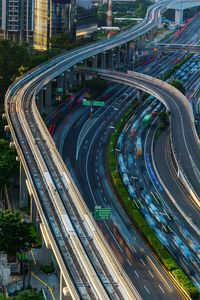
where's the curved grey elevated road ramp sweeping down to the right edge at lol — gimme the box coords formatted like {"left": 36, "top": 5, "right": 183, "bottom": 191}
{"left": 79, "top": 69, "right": 200, "bottom": 206}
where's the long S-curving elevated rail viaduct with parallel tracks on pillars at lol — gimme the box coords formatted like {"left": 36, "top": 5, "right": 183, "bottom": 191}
{"left": 5, "top": 0, "right": 200, "bottom": 299}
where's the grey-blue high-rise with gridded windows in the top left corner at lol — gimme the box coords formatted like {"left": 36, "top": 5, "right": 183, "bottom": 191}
{"left": 0, "top": 0, "right": 34, "bottom": 44}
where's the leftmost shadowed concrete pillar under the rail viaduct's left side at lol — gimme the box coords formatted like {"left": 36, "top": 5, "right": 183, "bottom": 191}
{"left": 19, "top": 162, "right": 29, "bottom": 208}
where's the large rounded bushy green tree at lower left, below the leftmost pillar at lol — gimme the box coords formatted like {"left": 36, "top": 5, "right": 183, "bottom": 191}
{"left": 0, "top": 210, "right": 35, "bottom": 258}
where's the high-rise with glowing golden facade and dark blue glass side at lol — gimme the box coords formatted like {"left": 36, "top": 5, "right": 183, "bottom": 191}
{"left": 34, "top": 0, "right": 76, "bottom": 50}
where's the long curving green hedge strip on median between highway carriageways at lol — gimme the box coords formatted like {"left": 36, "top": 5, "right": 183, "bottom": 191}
{"left": 107, "top": 101, "right": 199, "bottom": 299}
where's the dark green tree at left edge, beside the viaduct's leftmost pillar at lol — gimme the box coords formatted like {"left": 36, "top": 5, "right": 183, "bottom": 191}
{"left": 0, "top": 139, "right": 18, "bottom": 189}
